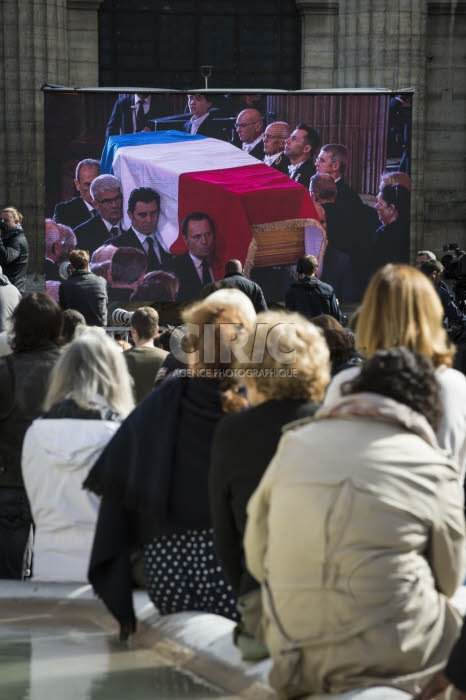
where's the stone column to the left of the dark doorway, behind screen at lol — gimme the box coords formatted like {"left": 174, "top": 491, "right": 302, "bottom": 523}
{"left": 0, "top": 0, "right": 100, "bottom": 274}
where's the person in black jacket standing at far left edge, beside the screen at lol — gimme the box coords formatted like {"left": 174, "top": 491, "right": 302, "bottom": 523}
{"left": 0, "top": 207, "right": 29, "bottom": 293}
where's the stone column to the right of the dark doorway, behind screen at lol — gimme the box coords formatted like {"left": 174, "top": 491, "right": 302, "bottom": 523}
{"left": 296, "top": 0, "right": 427, "bottom": 248}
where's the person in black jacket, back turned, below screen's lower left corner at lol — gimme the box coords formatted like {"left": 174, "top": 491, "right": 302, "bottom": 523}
{"left": 58, "top": 250, "right": 108, "bottom": 326}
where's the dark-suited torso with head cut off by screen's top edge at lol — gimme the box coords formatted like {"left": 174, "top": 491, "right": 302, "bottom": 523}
{"left": 105, "top": 92, "right": 166, "bottom": 139}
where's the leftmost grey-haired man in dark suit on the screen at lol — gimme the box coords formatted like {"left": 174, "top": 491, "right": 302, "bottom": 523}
{"left": 53, "top": 158, "right": 100, "bottom": 230}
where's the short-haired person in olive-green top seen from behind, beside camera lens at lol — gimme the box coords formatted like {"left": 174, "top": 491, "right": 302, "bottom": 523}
{"left": 124, "top": 306, "right": 168, "bottom": 403}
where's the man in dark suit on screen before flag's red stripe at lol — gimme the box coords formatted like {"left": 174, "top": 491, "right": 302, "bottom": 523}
{"left": 171, "top": 212, "right": 215, "bottom": 301}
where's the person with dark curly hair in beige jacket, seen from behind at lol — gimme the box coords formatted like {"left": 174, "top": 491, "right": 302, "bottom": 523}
{"left": 244, "top": 347, "right": 466, "bottom": 699}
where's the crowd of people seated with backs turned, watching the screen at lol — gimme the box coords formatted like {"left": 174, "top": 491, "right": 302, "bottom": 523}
{"left": 0, "top": 264, "right": 466, "bottom": 698}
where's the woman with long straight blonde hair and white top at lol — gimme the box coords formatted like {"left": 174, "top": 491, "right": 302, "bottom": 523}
{"left": 324, "top": 264, "right": 466, "bottom": 483}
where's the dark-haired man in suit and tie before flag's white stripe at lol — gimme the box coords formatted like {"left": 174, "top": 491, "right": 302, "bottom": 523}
{"left": 106, "top": 187, "right": 173, "bottom": 272}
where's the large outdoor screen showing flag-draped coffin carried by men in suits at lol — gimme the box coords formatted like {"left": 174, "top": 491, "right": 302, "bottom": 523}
{"left": 44, "top": 88, "right": 412, "bottom": 308}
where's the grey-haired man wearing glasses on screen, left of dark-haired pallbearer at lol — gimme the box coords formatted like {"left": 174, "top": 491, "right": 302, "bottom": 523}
{"left": 75, "top": 175, "right": 123, "bottom": 256}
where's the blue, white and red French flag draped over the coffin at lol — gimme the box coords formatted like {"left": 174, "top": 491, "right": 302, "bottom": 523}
{"left": 101, "top": 131, "right": 323, "bottom": 279}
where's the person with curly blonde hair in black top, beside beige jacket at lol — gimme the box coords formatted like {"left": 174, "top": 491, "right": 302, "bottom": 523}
{"left": 209, "top": 311, "right": 330, "bottom": 658}
